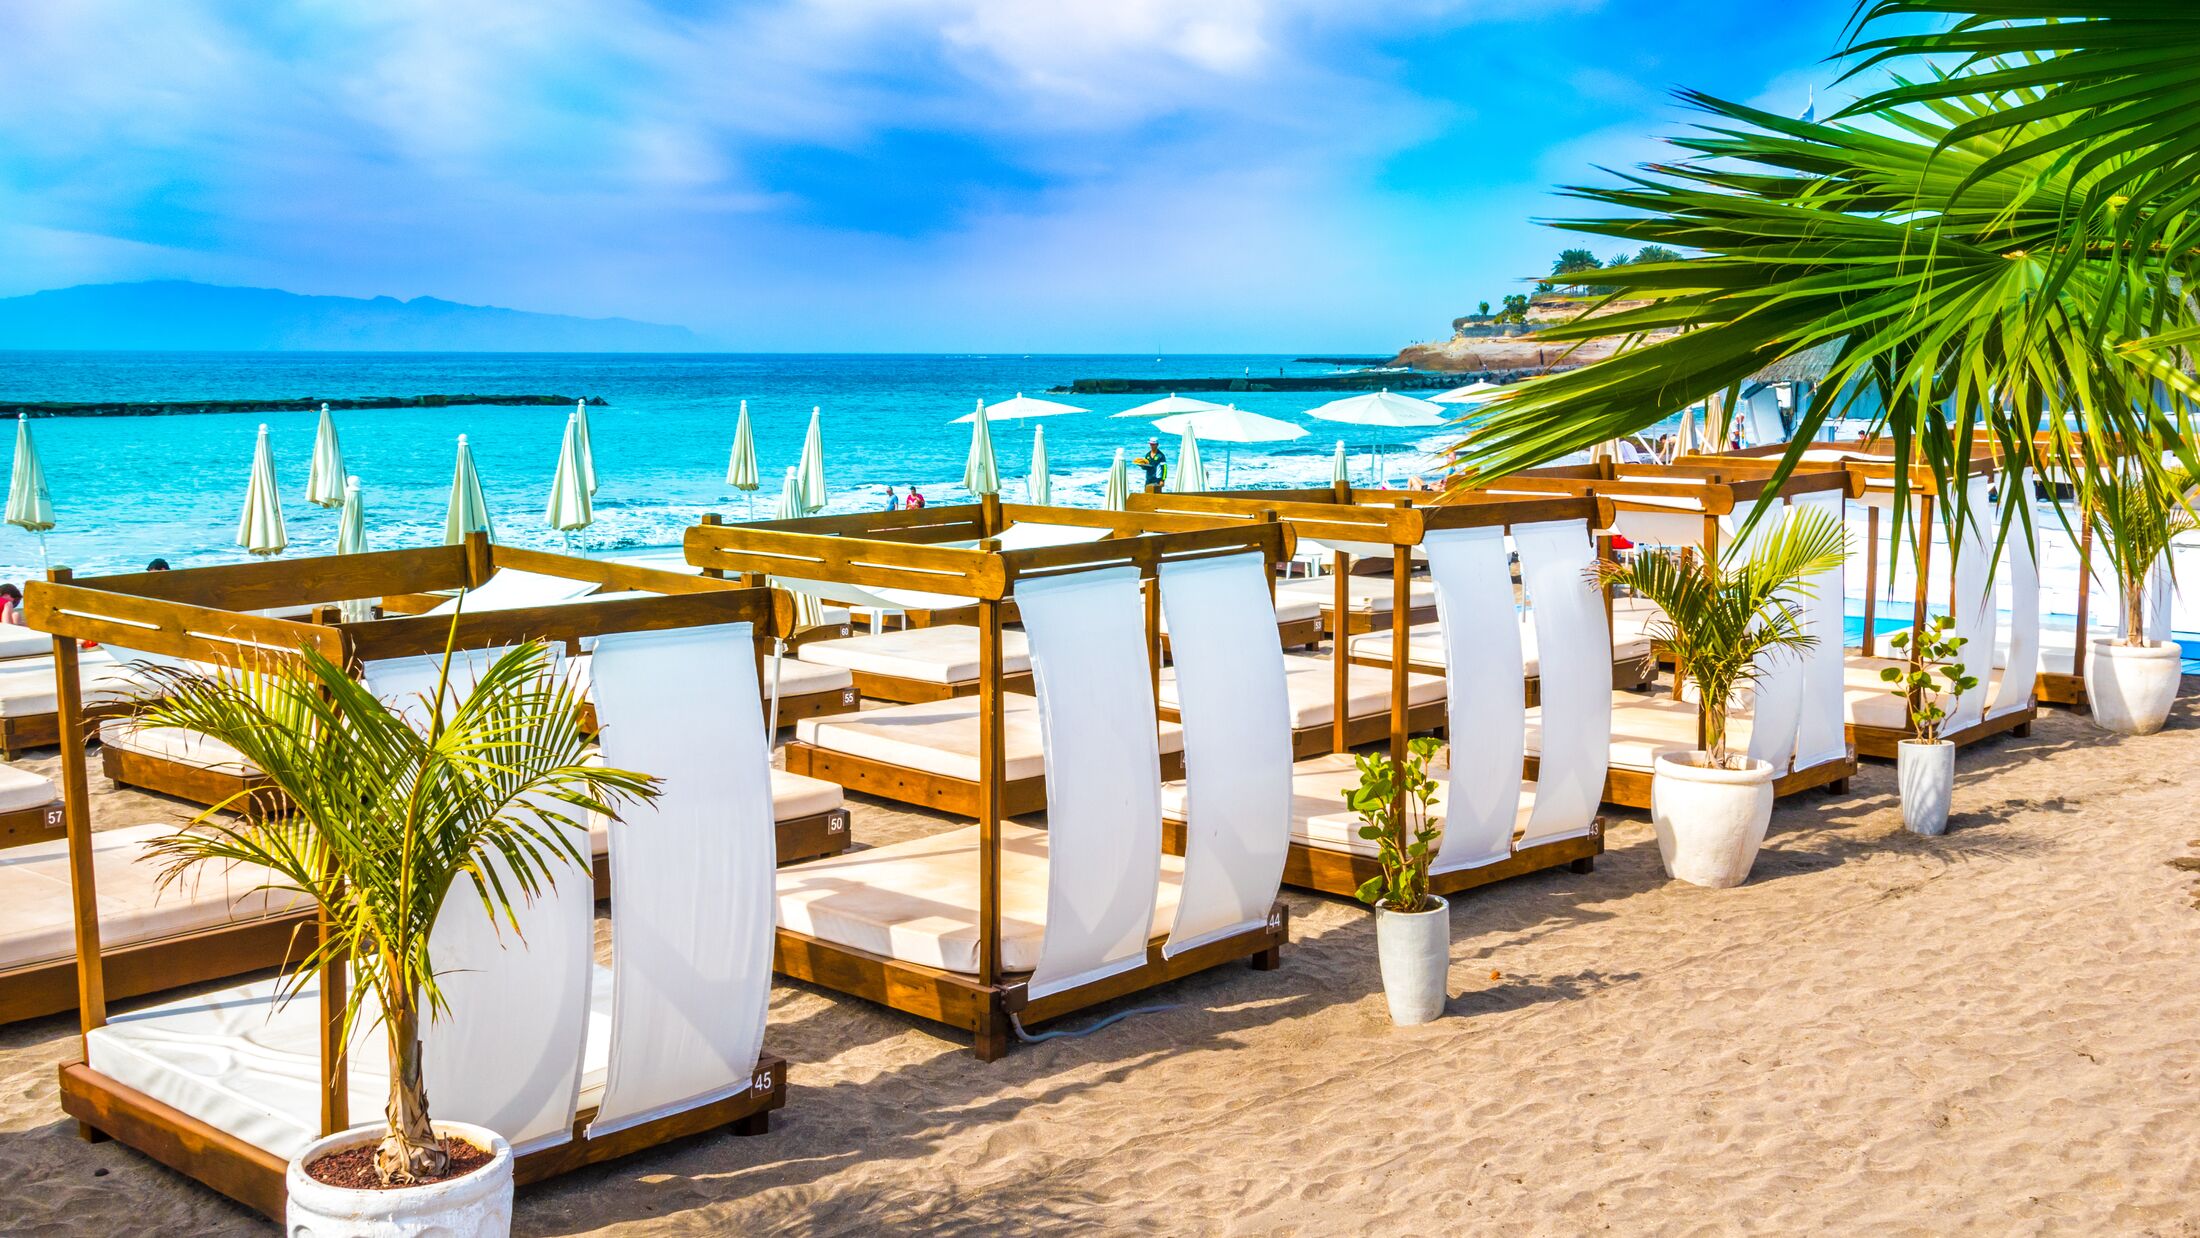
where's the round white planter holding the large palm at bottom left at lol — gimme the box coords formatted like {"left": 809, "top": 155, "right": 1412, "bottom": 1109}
{"left": 284, "top": 1121, "right": 513, "bottom": 1238}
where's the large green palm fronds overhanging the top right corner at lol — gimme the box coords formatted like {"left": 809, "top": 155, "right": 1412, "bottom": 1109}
{"left": 1459, "top": 0, "right": 2200, "bottom": 543}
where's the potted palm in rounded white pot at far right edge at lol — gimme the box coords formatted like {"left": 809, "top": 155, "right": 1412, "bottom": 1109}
{"left": 2079, "top": 460, "right": 2196, "bottom": 734}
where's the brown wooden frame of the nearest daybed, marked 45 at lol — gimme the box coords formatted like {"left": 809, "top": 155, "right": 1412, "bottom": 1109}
{"left": 19, "top": 534, "right": 792, "bottom": 1218}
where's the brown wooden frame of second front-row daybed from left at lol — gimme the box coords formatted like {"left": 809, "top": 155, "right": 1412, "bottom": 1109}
{"left": 686, "top": 508, "right": 1289, "bottom": 1062}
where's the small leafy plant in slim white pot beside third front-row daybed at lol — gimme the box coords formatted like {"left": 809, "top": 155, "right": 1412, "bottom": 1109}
{"left": 1344, "top": 737, "right": 1452, "bottom": 1027}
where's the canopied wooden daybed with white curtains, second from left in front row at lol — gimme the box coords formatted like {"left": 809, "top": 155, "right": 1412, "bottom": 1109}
{"left": 686, "top": 512, "right": 1289, "bottom": 1060}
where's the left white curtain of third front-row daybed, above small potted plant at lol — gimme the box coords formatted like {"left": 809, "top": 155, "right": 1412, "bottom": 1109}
{"left": 1423, "top": 528, "right": 1527, "bottom": 873}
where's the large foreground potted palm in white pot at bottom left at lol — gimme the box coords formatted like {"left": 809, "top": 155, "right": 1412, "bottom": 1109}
{"left": 147, "top": 642, "right": 656, "bottom": 1236}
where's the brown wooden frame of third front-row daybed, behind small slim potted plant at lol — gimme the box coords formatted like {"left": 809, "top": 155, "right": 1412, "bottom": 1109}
{"left": 1131, "top": 486, "right": 1613, "bottom": 897}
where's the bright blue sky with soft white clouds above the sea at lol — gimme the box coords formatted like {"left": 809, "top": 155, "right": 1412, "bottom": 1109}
{"left": 0, "top": 0, "right": 1852, "bottom": 352}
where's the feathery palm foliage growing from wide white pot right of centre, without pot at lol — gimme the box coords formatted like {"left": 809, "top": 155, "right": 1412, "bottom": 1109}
{"left": 1595, "top": 508, "right": 1848, "bottom": 770}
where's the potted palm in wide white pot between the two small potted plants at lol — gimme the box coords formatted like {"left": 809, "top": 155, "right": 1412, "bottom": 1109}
{"left": 1597, "top": 508, "right": 1848, "bottom": 888}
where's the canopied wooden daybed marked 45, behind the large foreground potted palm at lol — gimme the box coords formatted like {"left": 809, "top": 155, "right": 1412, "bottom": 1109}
{"left": 27, "top": 539, "right": 785, "bottom": 1218}
